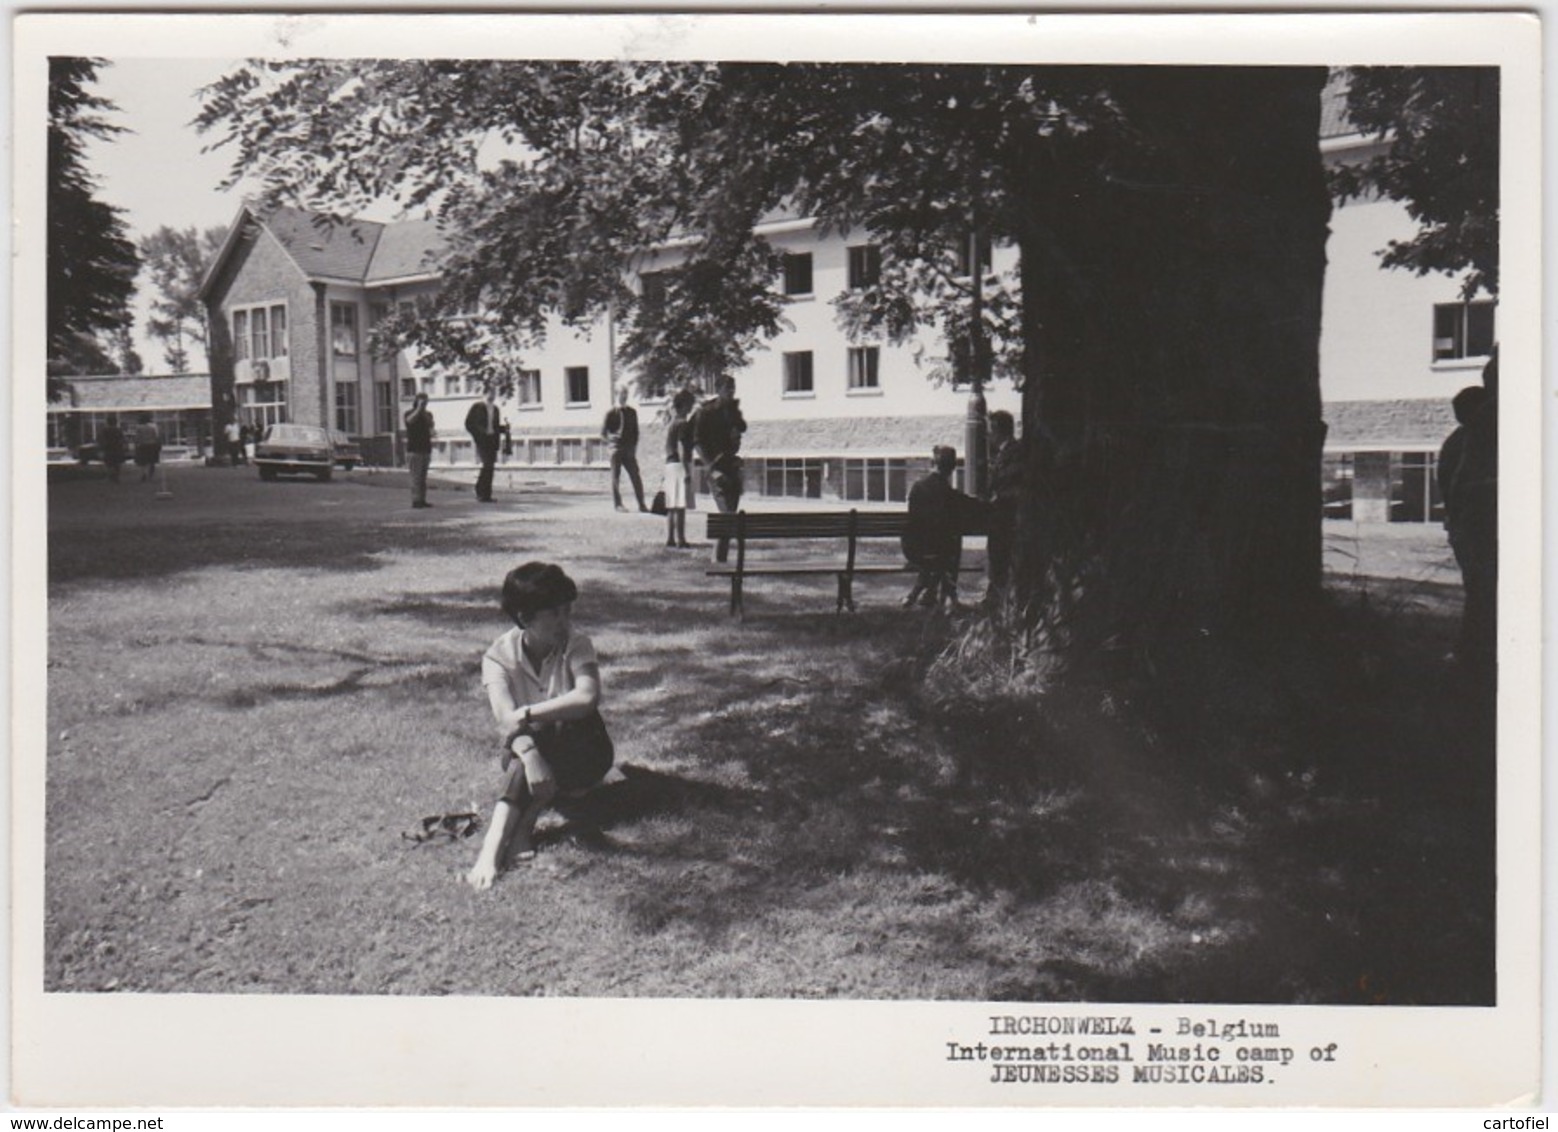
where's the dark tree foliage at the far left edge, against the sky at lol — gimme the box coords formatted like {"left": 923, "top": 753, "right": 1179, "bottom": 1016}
{"left": 47, "top": 58, "right": 139, "bottom": 378}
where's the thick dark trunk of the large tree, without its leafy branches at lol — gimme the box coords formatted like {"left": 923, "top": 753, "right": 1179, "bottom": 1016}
{"left": 1019, "top": 67, "right": 1331, "bottom": 660}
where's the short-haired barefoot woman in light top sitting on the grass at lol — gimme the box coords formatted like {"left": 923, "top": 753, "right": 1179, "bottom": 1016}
{"left": 466, "top": 562, "right": 614, "bottom": 892}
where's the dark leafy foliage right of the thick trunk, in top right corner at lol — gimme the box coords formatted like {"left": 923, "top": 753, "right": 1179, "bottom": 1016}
{"left": 1332, "top": 67, "right": 1499, "bottom": 299}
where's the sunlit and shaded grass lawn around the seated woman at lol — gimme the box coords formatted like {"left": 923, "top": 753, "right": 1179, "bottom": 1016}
{"left": 45, "top": 469, "right": 1494, "bottom": 1004}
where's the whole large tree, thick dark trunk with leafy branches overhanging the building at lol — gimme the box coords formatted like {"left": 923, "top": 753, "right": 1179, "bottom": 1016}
{"left": 199, "top": 61, "right": 1329, "bottom": 660}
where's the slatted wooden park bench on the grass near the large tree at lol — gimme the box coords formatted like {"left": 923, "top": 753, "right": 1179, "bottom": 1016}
{"left": 706, "top": 511, "right": 989, "bottom": 617}
